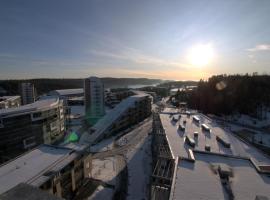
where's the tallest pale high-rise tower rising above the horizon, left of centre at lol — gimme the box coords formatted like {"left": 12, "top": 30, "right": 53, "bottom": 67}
{"left": 84, "top": 77, "right": 105, "bottom": 125}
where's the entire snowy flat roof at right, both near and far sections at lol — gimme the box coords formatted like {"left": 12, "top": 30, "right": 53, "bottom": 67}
{"left": 160, "top": 110, "right": 270, "bottom": 200}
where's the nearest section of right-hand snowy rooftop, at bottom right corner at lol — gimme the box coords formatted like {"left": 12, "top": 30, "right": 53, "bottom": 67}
{"left": 172, "top": 153, "right": 270, "bottom": 200}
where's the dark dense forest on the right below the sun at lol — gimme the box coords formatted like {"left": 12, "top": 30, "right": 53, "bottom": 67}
{"left": 186, "top": 74, "right": 270, "bottom": 117}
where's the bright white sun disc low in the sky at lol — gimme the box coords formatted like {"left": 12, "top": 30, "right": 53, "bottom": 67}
{"left": 188, "top": 44, "right": 214, "bottom": 67}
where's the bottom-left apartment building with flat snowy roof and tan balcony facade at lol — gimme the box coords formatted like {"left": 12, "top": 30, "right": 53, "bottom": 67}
{"left": 0, "top": 144, "right": 86, "bottom": 199}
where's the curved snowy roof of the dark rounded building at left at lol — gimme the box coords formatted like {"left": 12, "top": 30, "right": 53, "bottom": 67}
{"left": 0, "top": 98, "right": 59, "bottom": 117}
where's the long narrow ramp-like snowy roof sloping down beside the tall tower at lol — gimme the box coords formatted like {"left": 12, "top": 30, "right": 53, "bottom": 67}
{"left": 80, "top": 92, "right": 149, "bottom": 144}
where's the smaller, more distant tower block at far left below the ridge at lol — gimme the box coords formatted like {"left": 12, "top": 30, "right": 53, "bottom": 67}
{"left": 21, "top": 83, "right": 36, "bottom": 105}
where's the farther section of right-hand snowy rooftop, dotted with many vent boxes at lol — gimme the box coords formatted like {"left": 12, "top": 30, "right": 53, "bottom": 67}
{"left": 160, "top": 111, "right": 270, "bottom": 165}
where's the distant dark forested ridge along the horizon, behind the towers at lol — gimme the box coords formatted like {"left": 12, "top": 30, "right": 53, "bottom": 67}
{"left": 0, "top": 77, "right": 162, "bottom": 95}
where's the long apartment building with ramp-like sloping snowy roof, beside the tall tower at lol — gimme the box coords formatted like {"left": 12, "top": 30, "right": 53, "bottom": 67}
{"left": 80, "top": 91, "right": 152, "bottom": 144}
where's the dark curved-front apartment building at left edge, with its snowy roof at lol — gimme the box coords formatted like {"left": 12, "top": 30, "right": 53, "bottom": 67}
{"left": 0, "top": 98, "right": 65, "bottom": 163}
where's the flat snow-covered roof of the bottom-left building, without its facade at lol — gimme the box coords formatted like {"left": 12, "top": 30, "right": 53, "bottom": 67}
{"left": 0, "top": 145, "right": 77, "bottom": 194}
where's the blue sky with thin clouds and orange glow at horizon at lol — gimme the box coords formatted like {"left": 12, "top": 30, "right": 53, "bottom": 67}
{"left": 0, "top": 0, "right": 270, "bottom": 80}
